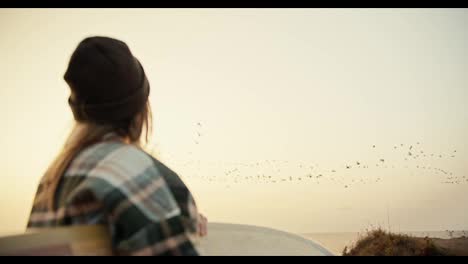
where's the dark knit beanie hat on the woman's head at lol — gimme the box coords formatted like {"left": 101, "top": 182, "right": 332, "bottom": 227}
{"left": 64, "top": 37, "right": 150, "bottom": 124}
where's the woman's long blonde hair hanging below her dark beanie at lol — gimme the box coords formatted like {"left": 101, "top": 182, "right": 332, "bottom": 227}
{"left": 34, "top": 101, "right": 152, "bottom": 210}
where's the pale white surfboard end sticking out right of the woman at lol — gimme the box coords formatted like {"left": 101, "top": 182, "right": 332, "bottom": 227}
{"left": 197, "top": 223, "right": 333, "bottom": 256}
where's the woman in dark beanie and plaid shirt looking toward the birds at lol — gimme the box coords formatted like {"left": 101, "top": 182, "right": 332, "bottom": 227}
{"left": 28, "top": 37, "right": 206, "bottom": 255}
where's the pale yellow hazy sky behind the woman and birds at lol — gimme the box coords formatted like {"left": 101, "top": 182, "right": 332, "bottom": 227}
{"left": 0, "top": 9, "right": 468, "bottom": 234}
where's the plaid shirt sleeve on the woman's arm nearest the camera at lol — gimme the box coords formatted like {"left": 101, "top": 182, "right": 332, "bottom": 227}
{"left": 98, "top": 152, "right": 199, "bottom": 256}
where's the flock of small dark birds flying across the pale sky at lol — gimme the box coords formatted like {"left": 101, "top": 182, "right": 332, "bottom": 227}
{"left": 165, "top": 122, "right": 468, "bottom": 188}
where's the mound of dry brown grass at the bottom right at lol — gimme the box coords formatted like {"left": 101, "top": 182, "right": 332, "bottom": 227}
{"left": 343, "top": 229, "right": 450, "bottom": 256}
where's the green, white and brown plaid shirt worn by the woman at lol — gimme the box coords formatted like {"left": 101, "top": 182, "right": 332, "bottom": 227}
{"left": 28, "top": 141, "right": 199, "bottom": 255}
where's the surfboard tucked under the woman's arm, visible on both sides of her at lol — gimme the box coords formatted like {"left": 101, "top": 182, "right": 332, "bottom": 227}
{"left": 0, "top": 223, "right": 332, "bottom": 256}
